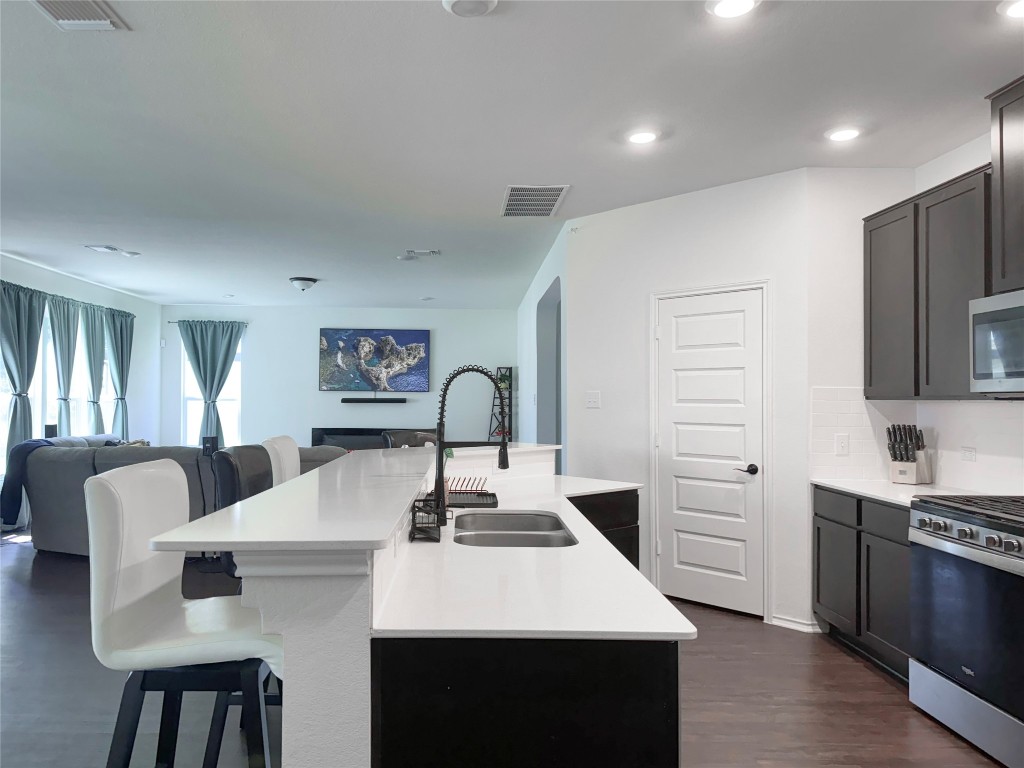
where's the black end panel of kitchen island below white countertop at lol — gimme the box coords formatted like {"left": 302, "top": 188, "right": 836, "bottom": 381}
{"left": 372, "top": 638, "right": 680, "bottom": 768}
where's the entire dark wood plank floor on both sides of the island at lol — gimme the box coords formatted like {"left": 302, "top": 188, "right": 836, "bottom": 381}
{"left": 0, "top": 544, "right": 995, "bottom": 768}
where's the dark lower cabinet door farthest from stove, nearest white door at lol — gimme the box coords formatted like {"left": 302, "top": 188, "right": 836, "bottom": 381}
{"left": 814, "top": 516, "right": 857, "bottom": 635}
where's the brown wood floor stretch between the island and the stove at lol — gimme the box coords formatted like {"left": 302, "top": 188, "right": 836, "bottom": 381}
{"left": 673, "top": 601, "right": 998, "bottom": 768}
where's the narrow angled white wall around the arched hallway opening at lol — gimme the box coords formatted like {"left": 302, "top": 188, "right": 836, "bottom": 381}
{"left": 516, "top": 224, "right": 571, "bottom": 456}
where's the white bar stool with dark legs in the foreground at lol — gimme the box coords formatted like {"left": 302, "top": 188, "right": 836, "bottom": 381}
{"left": 85, "top": 459, "right": 284, "bottom": 768}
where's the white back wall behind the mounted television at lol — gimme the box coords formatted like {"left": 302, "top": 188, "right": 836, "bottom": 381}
{"left": 161, "top": 306, "right": 516, "bottom": 445}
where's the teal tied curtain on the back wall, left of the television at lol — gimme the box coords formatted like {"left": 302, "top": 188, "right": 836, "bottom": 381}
{"left": 178, "top": 321, "right": 246, "bottom": 443}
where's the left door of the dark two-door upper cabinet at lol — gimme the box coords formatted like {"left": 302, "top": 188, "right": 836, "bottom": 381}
{"left": 864, "top": 203, "right": 921, "bottom": 399}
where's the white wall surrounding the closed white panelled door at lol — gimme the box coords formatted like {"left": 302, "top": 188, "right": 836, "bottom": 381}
{"left": 566, "top": 171, "right": 811, "bottom": 623}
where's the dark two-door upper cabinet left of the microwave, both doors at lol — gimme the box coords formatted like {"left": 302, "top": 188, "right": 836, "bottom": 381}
{"left": 864, "top": 166, "right": 991, "bottom": 400}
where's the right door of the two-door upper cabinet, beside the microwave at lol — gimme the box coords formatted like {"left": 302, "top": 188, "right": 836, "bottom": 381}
{"left": 918, "top": 167, "right": 990, "bottom": 398}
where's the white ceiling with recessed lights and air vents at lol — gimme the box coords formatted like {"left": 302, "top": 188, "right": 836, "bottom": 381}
{"left": 0, "top": 0, "right": 1024, "bottom": 307}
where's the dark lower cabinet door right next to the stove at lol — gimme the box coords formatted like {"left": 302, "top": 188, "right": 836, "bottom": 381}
{"left": 860, "top": 532, "right": 910, "bottom": 677}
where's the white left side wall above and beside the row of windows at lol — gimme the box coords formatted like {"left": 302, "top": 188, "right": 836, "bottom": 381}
{"left": 0, "top": 255, "right": 160, "bottom": 444}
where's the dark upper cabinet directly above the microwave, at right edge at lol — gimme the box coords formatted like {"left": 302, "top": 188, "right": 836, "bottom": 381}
{"left": 988, "top": 78, "right": 1024, "bottom": 293}
